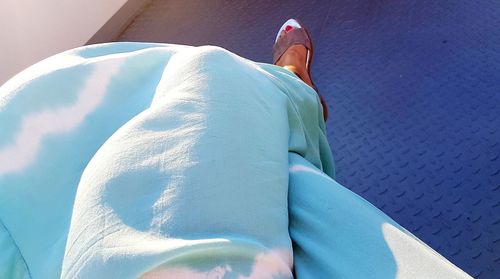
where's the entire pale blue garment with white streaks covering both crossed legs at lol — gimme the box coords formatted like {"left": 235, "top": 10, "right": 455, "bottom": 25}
{"left": 0, "top": 43, "right": 468, "bottom": 278}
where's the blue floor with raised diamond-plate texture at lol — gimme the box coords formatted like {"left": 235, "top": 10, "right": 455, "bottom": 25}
{"left": 119, "top": 0, "right": 500, "bottom": 278}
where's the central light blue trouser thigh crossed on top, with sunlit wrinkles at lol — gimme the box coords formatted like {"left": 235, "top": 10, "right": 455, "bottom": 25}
{"left": 62, "top": 47, "right": 292, "bottom": 278}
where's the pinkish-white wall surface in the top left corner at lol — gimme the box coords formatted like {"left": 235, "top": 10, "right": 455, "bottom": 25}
{"left": 0, "top": 0, "right": 127, "bottom": 85}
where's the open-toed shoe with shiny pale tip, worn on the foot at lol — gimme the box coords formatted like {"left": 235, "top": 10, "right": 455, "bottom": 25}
{"left": 273, "top": 18, "right": 328, "bottom": 121}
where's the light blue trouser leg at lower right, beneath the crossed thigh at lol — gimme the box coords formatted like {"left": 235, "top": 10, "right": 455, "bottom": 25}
{"left": 289, "top": 153, "right": 470, "bottom": 278}
